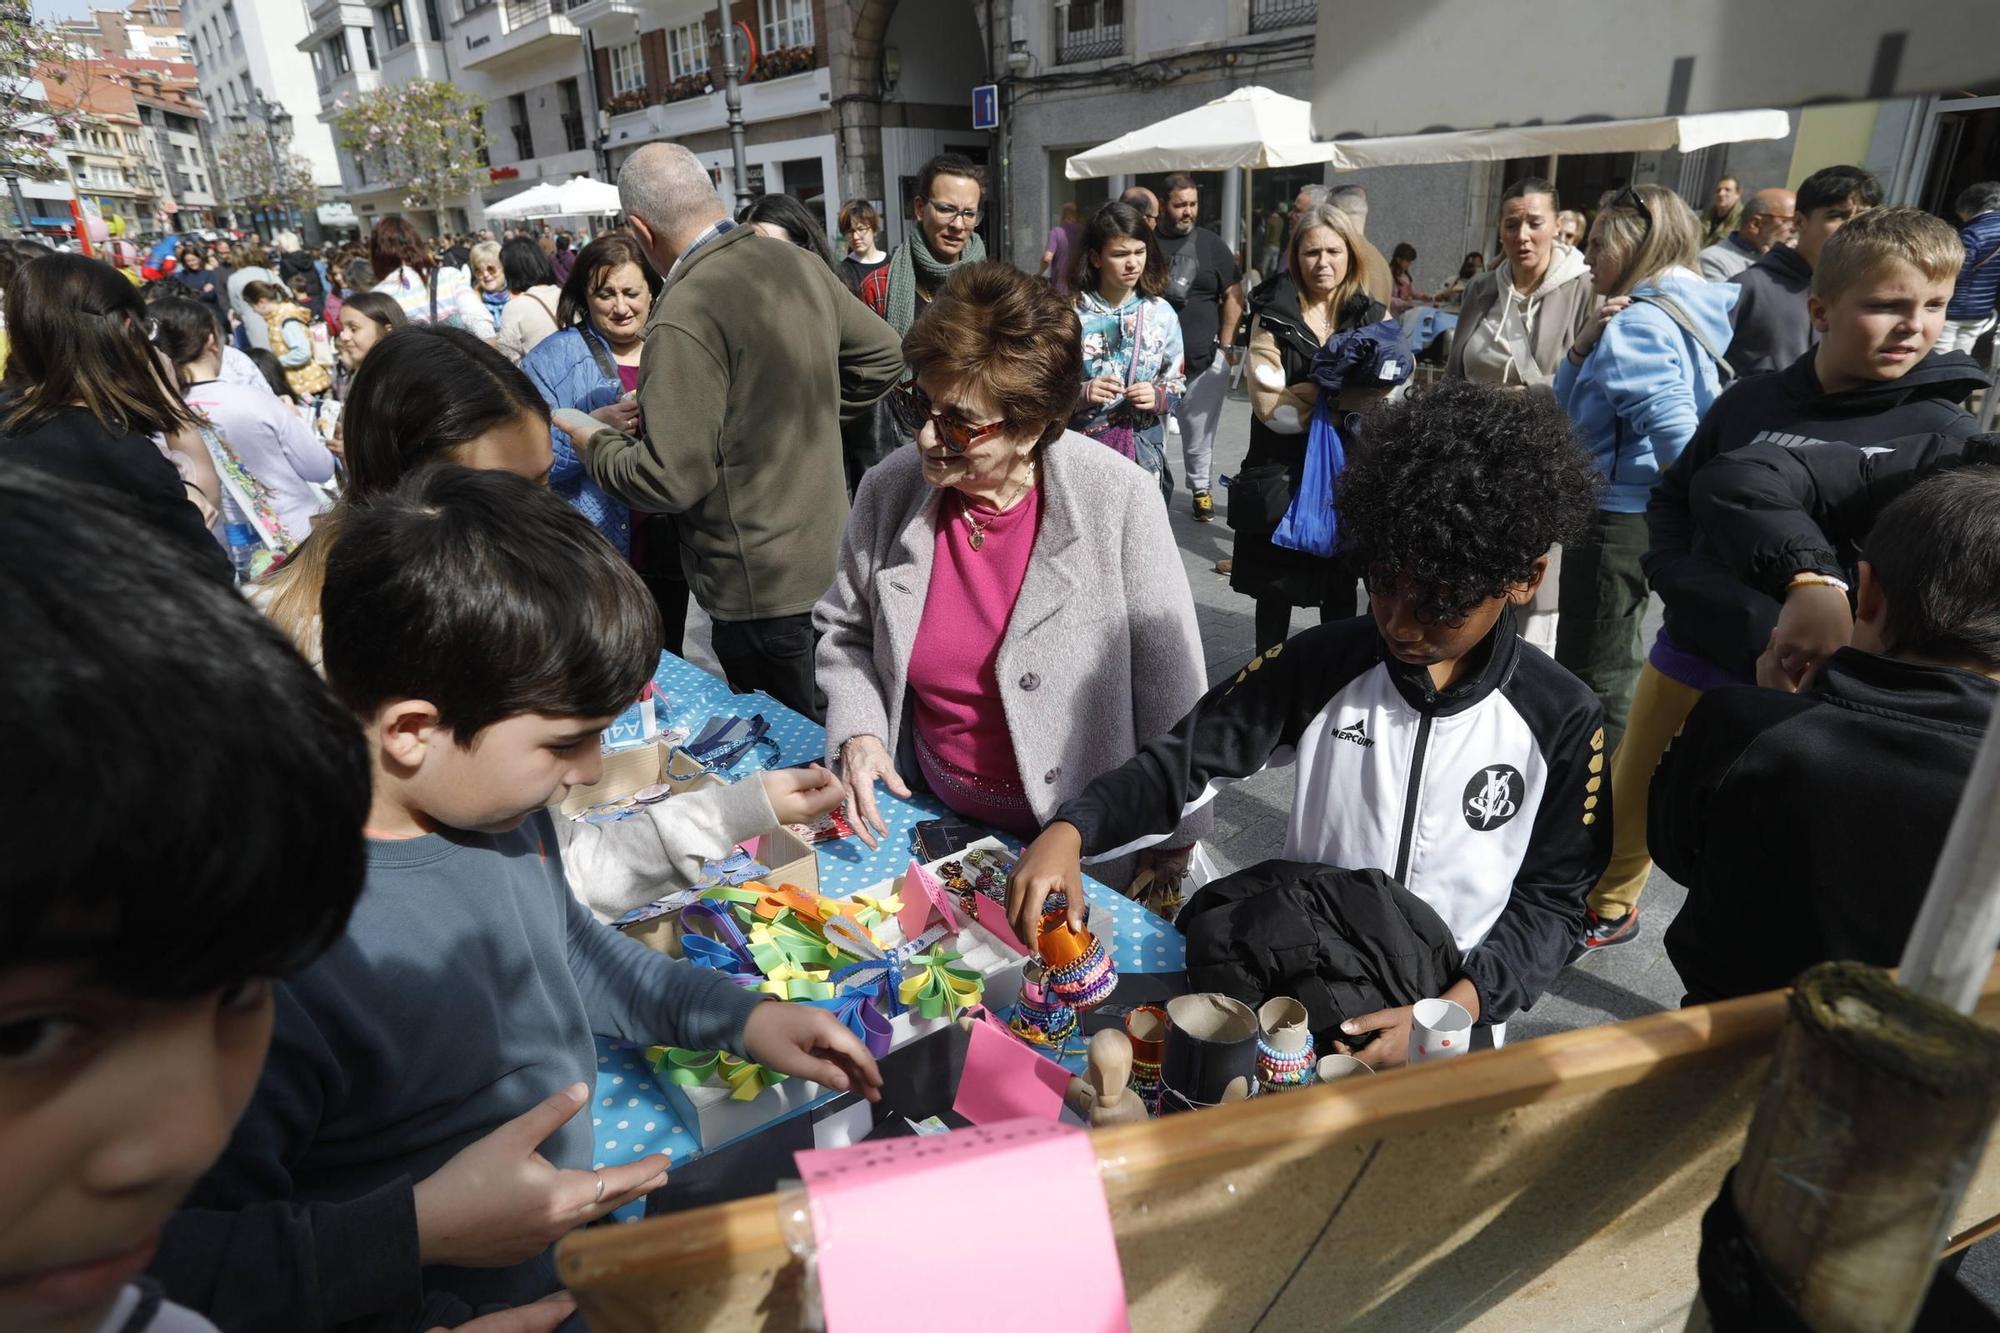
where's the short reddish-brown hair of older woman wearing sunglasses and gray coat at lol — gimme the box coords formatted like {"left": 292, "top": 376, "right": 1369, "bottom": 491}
{"left": 902, "top": 262, "right": 1084, "bottom": 450}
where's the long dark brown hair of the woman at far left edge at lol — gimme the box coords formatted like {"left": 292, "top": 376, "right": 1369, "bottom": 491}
{"left": 0, "top": 254, "right": 196, "bottom": 434}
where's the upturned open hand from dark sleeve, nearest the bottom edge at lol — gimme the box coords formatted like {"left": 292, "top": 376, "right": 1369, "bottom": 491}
{"left": 416, "top": 1072, "right": 672, "bottom": 1269}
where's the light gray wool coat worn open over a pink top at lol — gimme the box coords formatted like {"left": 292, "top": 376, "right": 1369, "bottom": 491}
{"left": 812, "top": 430, "right": 1210, "bottom": 885}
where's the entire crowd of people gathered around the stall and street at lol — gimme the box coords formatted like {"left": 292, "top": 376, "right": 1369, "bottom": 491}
{"left": 0, "top": 144, "right": 2000, "bottom": 1329}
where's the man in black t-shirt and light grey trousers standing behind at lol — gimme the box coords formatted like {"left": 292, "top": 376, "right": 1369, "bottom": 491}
{"left": 1154, "top": 172, "right": 1244, "bottom": 522}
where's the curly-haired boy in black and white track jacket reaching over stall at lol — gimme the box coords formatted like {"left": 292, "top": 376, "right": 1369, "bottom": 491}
{"left": 1010, "top": 382, "right": 1610, "bottom": 1067}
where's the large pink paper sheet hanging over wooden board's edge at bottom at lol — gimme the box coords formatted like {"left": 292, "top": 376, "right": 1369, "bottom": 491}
{"left": 796, "top": 1112, "right": 1132, "bottom": 1333}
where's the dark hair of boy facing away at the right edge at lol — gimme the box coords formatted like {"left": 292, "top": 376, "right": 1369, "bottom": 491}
{"left": 1862, "top": 466, "right": 2000, "bottom": 671}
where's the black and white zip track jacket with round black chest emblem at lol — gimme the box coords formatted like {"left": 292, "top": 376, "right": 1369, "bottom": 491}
{"left": 1056, "top": 608, "right": 1612, "bottom": 1023}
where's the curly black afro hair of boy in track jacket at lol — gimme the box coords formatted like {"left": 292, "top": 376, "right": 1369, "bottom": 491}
{"left": 1334, "top": 380, "right": 1598, "bottom": 622}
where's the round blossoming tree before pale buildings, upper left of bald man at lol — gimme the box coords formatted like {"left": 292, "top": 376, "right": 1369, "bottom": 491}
{"left": 334, "top": 78, "right": 486, "bottom": 208}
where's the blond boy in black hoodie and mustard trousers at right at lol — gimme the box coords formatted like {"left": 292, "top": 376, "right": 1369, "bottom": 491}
{"left": 1580, "top": 208, "right": 1986, "bottom": 951}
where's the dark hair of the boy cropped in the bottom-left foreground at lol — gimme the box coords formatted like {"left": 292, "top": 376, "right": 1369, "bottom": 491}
{"left": 0, "top": 462, "right": 368, "bottom": 999}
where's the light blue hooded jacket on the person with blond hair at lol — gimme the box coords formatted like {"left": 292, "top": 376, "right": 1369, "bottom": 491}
{"left": 1556, "top": 268, "right": 1738, "bottom": 514}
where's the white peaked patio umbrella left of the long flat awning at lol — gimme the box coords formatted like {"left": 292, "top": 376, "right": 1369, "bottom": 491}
{"left": 1062, "top": 88, "right": 1340, "bottom": 180}
